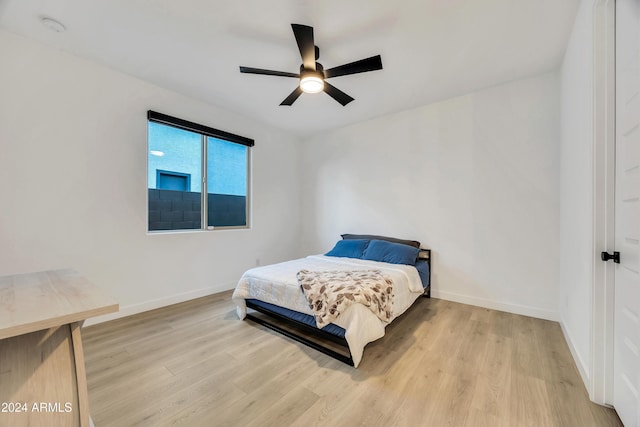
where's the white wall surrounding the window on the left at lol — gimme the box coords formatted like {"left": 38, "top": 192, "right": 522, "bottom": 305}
{"left": 0, "top": 31, "right": 300, "bottom": 322}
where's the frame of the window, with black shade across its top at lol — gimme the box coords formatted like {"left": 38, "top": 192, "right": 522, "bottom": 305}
{"left": 146, "top": 110, "right": 255, "bottom": 234}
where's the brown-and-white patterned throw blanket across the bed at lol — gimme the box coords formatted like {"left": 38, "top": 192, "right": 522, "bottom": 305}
{"left": 296, "top": 270, "right": 393, "bottom": 328}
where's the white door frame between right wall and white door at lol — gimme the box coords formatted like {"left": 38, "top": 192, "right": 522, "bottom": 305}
{"left": 586, "top": 0, "right": 616, "bottom": 406}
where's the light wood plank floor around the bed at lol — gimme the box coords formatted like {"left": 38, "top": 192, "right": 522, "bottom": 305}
{"left": 83, "top": 292, "right": 621, "bottom": 427}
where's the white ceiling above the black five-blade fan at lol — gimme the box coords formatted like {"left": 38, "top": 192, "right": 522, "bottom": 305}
{"left": 0, "top": 0, "right": 579, "bottom": 135}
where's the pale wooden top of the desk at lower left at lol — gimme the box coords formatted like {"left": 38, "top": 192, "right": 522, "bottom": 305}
{"left": 0, "top": 270, "right": 118, "bottom": 339}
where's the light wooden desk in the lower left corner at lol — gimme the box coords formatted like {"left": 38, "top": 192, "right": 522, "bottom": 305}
{"left": 0, "top": 270, "right": 118, "bottom": 427}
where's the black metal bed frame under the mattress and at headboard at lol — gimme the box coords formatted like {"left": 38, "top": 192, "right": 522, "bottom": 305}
{"left": 246, "top": 249, "right": 431, "bottom": 366}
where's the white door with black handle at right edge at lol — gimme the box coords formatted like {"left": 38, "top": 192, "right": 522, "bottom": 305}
{"left": 613, "top": 0, "right": 640, "bottom": 427}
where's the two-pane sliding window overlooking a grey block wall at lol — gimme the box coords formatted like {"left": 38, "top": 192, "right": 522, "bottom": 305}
{"left": 147, "top": 111, "right": 254, "bottom": 231}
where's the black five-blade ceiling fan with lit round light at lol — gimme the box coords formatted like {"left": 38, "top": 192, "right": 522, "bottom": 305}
{"left": 240, "top": 24, "right": 382, "bottom": 106}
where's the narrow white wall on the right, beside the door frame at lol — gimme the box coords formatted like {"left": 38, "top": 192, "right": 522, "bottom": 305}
{"left": 559, "top": 0, "right": 594, "bottom": 383}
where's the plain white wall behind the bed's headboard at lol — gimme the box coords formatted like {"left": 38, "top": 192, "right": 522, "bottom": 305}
{"left": 302, "top": 73, "right": 560, "bottom": 319}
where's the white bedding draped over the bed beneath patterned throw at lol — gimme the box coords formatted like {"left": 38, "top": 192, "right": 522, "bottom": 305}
{"left": 232, "top": 255, "right": 424, "bottom": 367}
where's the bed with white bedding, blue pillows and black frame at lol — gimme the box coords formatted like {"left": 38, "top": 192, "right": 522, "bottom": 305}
{"left": 232, "top": 234, "right": 431, "bottom": 367}
